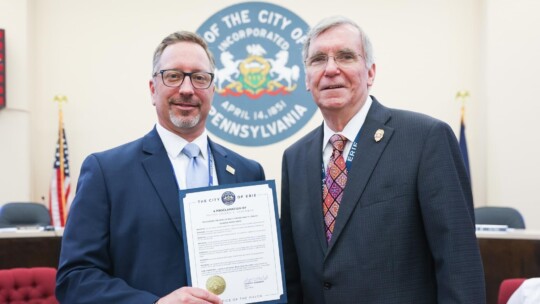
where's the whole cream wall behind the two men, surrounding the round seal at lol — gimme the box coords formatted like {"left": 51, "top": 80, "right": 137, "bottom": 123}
{"left": 0, "top": 0, "right": 540, "bottom": 229}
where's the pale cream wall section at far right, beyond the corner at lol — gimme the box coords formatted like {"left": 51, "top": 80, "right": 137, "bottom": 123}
{"left": 483, "top": 0, "right": 540, "bottom": 223}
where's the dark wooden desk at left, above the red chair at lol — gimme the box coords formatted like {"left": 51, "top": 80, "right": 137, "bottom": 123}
{"left": 0, "top": 231, "right": 62, "bottom": 269}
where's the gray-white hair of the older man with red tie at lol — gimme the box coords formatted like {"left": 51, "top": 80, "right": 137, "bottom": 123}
{"left": 302, "top": 16, "right": 375, "bottom": 69}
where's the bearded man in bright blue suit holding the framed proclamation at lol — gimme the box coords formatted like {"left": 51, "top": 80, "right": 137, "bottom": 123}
{"left": 56, "top": 32, "right": 265, "bottom": 304}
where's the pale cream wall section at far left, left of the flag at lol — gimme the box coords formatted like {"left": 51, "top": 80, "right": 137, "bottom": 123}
{"left": 0, "top": 0, "right": 31, "bottom": 204}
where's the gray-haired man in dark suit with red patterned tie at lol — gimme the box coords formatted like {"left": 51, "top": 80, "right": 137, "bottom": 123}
{"left": 281, "top": 17, "right": 485, "bottom": 304}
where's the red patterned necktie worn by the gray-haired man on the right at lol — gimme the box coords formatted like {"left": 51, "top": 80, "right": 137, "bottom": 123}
{"left": 323, "top": 134, "right": 347, "bottom": 243}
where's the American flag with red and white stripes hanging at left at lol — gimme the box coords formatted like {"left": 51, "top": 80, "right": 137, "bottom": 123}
{"left": 49, "top": 122, "right": 71, "bottom": 227}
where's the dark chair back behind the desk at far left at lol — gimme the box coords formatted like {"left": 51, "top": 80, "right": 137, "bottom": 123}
{"left": 0, "top": 203, "right": 51, "bottom": 228}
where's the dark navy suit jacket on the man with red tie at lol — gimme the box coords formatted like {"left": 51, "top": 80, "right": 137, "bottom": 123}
{"left": 281, "top": 99, "right": 485, "bottom": 304}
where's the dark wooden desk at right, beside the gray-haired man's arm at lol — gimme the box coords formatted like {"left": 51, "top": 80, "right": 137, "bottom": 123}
{"left": 476, "top": 230, "right": 540, "bottom": 304}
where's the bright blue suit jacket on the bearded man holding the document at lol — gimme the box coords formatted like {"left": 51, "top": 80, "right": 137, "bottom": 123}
{"left": 56, "top": 129, "right": 265, "bottom": 303}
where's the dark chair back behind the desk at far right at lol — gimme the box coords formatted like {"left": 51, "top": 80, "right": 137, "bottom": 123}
{"left": 474, "top": 207, "right": 525, "bottom": 229}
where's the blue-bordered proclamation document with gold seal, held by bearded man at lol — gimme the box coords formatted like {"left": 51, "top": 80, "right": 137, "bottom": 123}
{"left": 180, "top": 180, "right": 287, "bottom": 304}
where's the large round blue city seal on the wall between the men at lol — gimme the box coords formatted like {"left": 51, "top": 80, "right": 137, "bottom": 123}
{"left": 197, "top": 2, "right": 317, "bottom": 146}
